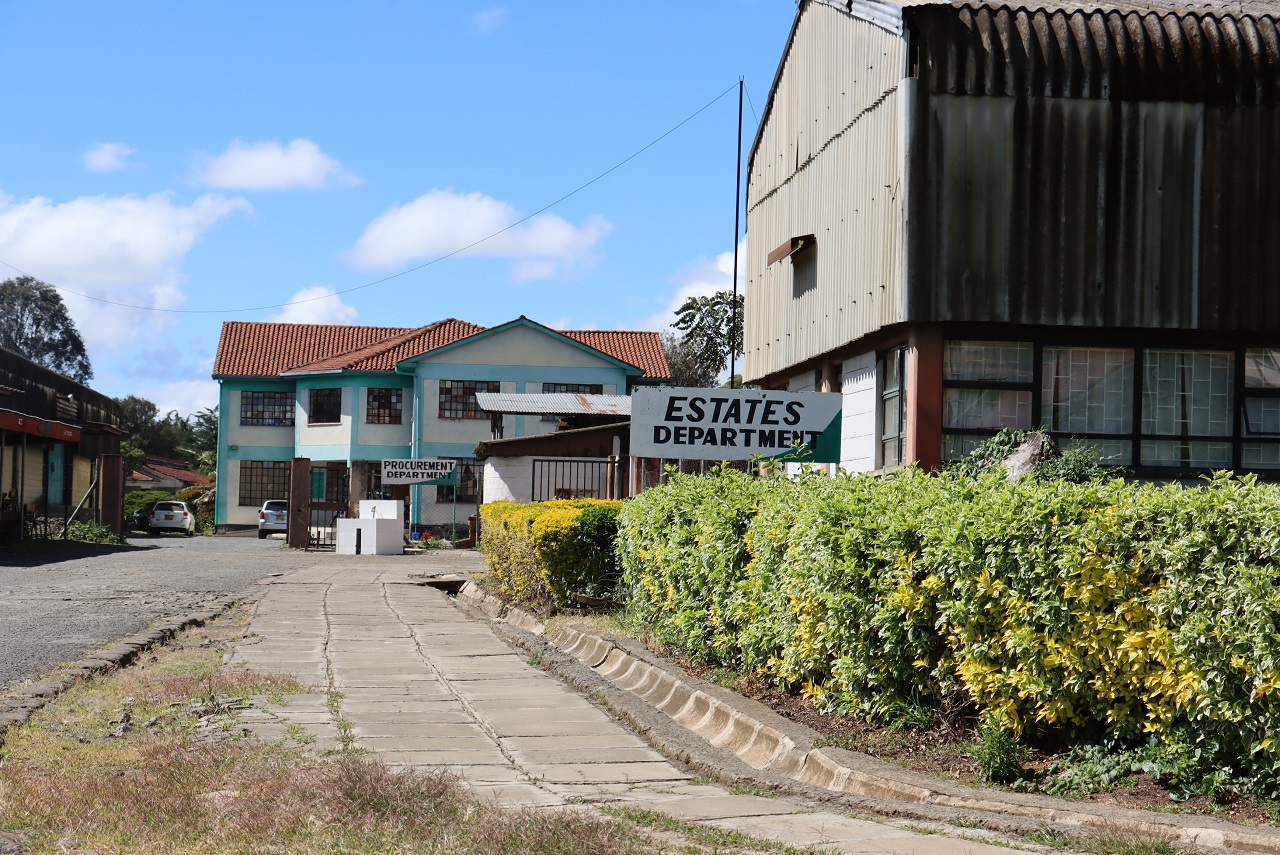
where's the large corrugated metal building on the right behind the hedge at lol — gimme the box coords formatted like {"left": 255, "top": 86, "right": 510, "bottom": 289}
{"left": 744, "top": 0, "right": 1280, "bottom": 477}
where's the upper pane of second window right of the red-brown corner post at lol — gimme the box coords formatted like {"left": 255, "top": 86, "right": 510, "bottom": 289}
{"left": 1041, "top": 347, "right": 1134, "bottom": 434}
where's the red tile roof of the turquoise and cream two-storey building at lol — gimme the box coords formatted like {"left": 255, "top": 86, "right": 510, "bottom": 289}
{"left": 214, "top": 317, "right": 671, "bottom": 379}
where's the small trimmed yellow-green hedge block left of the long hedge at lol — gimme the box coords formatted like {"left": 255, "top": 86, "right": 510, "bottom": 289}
{"left": 480, "top": 499, "right": 622, "bottom": 612}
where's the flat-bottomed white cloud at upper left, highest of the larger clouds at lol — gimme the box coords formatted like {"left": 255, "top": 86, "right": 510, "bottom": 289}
{"left": 195, "top": 140, "right": 360, "bottom": 189}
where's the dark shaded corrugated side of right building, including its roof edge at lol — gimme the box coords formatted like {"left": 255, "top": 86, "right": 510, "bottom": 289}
{"left": 909, "top": 6, "right": 1280, "bottom": 332}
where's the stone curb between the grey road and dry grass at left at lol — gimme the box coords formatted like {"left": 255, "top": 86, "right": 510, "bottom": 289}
{"left": 0, "top": 596, "right": 246, "bottom": 747}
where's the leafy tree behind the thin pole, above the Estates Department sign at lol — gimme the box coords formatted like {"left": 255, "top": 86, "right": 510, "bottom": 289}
{"left": 663, "top": 291, "right": 745, "bottom": 387}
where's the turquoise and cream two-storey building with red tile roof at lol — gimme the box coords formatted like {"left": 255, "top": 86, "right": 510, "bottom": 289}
{"left": 214, "top": 315, "right": 671, "bottom": 530}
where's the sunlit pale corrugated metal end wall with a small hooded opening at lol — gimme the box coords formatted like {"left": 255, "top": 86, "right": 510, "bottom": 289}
{"left": 744, "top": 3, "right": 913, "bottom": 380}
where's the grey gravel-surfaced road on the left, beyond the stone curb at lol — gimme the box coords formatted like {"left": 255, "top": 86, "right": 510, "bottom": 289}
{"left": 0, "top": 532, "right": 320, "bottom": 694}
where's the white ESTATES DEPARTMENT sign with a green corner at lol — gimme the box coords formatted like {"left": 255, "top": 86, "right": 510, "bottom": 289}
{"left": 631, "top": 387, "right": 844, "bottom": 463}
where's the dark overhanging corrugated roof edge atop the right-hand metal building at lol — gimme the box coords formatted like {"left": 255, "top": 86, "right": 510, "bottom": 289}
{"left": 902, "top": 1, "right": 1280, "bottom": 105}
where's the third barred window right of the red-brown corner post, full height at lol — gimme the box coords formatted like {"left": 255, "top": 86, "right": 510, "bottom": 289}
{"left": 1140, "top": 349, "right": 1235, "bottom": 468}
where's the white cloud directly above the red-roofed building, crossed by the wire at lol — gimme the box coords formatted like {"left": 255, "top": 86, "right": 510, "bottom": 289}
{"left": 347, "top": 189, "right": 613, "bottom": 282}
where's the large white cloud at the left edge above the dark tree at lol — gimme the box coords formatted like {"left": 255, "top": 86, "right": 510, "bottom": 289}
{"left": 0, "top": 192, "right": 252, "bottom": 352}
